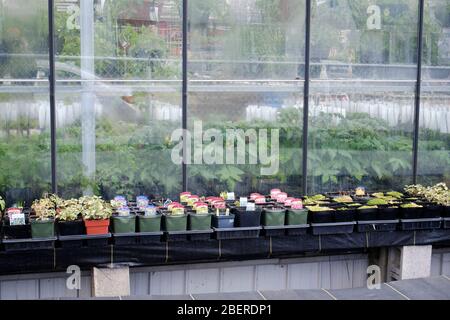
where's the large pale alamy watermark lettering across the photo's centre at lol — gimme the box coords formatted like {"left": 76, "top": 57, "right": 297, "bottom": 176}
{"left": 171, "top": 121, "right": 280, "bottom": 176}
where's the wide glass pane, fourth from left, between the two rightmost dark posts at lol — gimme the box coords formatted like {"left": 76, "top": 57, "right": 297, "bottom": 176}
{"left": 308, "top": 0, "right": 418, "bottom": 193}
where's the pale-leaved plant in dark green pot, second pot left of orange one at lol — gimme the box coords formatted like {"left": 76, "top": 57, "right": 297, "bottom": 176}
{"left": 30, "top": 197, "right": 56, "bottom": 238}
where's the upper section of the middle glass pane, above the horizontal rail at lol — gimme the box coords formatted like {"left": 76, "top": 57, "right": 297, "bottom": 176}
{"left": 189, "top": 0, "right": 305, "bottom": 80}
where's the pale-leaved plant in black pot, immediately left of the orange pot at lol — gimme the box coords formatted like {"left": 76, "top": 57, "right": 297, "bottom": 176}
{"left": 56, "top": 199, "right": 85, "bottom": 236}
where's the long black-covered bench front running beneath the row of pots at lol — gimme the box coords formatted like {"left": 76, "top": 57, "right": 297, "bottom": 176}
{"left": 0, "top": 227, "right": 450, "bottom": 275}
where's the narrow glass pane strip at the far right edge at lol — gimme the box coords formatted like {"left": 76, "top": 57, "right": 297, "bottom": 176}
{"left": 418, "top": 0, "right": 450, "bottom": 185}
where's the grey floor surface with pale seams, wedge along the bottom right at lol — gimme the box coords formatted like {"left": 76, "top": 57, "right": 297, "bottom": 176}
{"left": 52, "top": 276, "right": 450, "bottom": 300}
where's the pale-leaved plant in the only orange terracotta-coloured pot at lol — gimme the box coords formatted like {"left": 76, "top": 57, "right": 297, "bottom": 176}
{"left": 80, "top": 196, "right": 112, "bottom": 235}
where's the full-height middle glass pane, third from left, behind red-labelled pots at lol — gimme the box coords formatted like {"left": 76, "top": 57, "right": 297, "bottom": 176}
{"left": 188, "top": 0, "right": 305, "bottom": 195}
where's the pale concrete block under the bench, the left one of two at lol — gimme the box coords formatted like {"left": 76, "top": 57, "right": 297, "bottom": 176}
{"left": 92, "top": 267, "right": 130, "bottom": 297}
